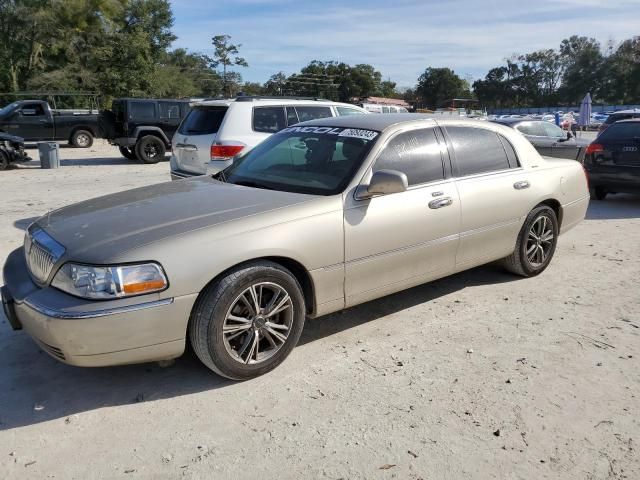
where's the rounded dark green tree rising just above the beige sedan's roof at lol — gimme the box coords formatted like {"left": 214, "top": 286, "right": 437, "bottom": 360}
{"left": 416, "top": 67, "right": 471, "bottom": 108}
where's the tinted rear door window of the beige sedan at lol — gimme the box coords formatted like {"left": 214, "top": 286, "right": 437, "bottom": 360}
{"left": 447, "top": 127, "right": 515, "bottom": 177}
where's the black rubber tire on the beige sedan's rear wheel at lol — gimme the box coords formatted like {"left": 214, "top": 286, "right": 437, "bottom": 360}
{"left": 502, "top": 205, "right": 559, "bottom": 277}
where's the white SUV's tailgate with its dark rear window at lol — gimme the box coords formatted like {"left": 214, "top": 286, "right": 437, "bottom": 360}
{"left": 173, "top": 105, "right": 228, "bottom": 175}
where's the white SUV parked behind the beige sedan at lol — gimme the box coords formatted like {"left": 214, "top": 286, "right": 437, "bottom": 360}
{"left": 171, "top": 96, "right": 368, "bottom": 180}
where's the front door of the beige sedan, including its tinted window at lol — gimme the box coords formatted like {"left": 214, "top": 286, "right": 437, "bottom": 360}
{"left": 344, "top": 128, "right": 460, "bottom": 306}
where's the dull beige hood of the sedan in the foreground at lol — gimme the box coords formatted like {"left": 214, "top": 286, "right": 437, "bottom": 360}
{"left": 36, "top": 176, "right": 317, "bottom": 262}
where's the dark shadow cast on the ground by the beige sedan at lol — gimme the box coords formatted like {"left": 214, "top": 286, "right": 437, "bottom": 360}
{"left": 0, "top": 265, "right": 517, "bottom": 430}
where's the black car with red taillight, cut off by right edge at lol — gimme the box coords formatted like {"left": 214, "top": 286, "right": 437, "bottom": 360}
{"left": 584, "top": 118, "right": 640, "bottom": 200}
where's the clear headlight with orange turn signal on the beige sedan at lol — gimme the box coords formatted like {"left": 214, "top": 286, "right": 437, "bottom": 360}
{"left": 51, "top": 263, "right": 168, "bottom": 300}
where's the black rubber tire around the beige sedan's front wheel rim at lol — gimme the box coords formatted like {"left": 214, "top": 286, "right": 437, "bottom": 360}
{"left": 189, "top": 261, "right": 306, "bottom": 380}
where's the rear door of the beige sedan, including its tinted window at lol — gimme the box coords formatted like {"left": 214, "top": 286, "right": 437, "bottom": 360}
{"left": 446, "top": 125, "right": 531, "bottom": 269}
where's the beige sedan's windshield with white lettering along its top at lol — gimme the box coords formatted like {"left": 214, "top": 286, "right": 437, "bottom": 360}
{"left": 224, "top": 126, "right": 378, "bottom": 195}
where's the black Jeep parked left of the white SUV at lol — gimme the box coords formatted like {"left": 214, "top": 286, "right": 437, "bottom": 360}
{"left": 98, "top": 98, "right": 190, "bottom": 163}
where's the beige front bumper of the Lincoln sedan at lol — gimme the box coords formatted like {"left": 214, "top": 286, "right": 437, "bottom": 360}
{"left": 2, "top": 248, "right": 196, "bottom": 367}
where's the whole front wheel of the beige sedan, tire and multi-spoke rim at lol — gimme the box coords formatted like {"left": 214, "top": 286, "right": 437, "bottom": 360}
{"left": 189, "top": 261, "right": 305, "bottom": 380}
